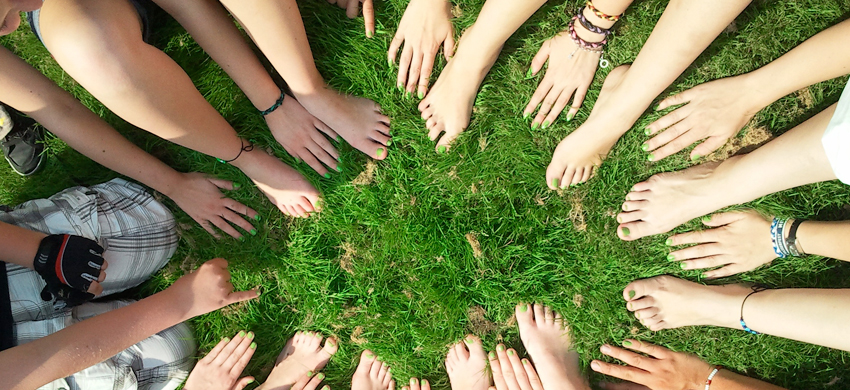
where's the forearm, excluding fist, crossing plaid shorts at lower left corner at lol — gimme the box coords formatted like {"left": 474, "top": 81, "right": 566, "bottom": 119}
{"left": 0, "top": 290, "right": 189, "bottom": 390}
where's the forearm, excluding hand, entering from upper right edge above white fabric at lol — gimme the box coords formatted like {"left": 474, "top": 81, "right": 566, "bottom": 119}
{"left": 744, "top": 20, "right": 850, "bottom": 108}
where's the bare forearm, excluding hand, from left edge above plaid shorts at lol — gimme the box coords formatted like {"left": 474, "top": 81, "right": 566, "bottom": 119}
{"left": 0, "top": 49, "right": 186, "bottom": 200}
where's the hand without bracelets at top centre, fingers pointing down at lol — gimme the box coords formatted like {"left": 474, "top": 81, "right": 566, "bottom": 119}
{"left": 387, "top": 0, "right": 455, "bottom": 99}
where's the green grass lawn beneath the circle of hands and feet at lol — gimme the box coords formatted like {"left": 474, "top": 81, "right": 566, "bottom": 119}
{"left": 0, "top": 0, "right": 850, "bottom": 389}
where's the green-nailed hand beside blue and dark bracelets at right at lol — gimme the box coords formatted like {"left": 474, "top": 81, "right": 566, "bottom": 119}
{"left": 667, "top": 210, "right": 776, "bottom": 279}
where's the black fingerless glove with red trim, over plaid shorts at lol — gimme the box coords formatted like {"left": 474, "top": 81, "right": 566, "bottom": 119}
{"left": 33, "top": 234, "right": 103, "bottom": 307}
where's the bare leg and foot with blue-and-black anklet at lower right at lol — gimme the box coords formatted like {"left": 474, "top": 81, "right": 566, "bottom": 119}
{"left": 623, "top": 276, "right": 850, "bottom": 351}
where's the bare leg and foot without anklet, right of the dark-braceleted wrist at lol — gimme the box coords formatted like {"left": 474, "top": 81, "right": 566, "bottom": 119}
{"left": 221, "top": 0, "right": 390, "bottom": 159}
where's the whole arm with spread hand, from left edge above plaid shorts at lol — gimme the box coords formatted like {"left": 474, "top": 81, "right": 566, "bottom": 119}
{"left": 0, "top": 48, "right": 257, "bottom": 237}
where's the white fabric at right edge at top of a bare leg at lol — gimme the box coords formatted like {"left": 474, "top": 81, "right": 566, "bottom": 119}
{"left": 821, "top": 83, "right": 850, "bottom": 185}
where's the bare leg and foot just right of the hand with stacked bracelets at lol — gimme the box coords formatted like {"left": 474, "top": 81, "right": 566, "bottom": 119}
{"left": 546, "top": 0, "right": 750, "bottom": 189}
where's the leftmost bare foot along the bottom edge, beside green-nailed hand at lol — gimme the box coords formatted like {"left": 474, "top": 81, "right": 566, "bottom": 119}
{"left": 260, "top": 332, "right": 338, "bottom": 390}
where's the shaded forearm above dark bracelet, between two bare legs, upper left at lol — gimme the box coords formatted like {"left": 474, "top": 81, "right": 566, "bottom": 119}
{"left": 155, "top": 0, "right": 280, "bottom": 110}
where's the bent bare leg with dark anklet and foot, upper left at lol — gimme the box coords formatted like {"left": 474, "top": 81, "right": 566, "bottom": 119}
{"left": 41, "top": 0, "right": 319, "bottom": 216}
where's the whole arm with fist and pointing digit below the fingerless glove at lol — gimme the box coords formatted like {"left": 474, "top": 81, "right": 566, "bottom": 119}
{"left": 0, "top": 259, "right": 258, "bottom": 390}
